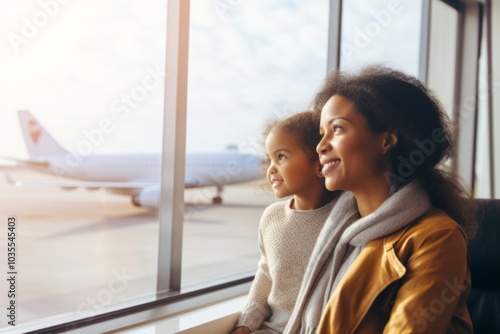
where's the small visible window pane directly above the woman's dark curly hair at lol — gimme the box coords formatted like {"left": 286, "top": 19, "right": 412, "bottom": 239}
{"left": 340, "top": 0, "right": 422, "bottom": 76}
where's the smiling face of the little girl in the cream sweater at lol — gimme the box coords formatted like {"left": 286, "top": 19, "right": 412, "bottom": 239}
{"left": 265, "top": 129, "right": 321, "bottom": 198}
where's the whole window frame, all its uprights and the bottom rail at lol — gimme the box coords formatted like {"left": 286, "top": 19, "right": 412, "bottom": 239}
{"left": 19, "top": 0, "right": 492, "bottom": 333}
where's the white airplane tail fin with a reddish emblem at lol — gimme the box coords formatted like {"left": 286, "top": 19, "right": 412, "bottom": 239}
{"left": 17, "top": 110, "right": 67, "bottom": 158}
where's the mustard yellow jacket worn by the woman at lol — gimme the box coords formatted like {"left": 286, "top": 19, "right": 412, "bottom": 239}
{"left": 318, "top": 209, "right": 473, "bottom": 334}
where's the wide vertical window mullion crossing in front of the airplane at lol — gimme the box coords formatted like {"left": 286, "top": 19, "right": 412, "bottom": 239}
{"left": 156, "top": 0, "right": 190, "bottom": 295}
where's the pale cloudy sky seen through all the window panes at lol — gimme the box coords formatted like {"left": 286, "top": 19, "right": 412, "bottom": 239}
{"left": 0, "top": 0, "right": 421, "bottom": 162}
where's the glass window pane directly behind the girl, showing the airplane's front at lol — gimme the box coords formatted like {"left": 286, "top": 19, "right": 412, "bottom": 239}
{"left": 182, "top": 0, "right": 329, "bottom": 286}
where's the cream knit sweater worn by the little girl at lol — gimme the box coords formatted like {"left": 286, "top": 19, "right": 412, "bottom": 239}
{"left": 237, "top": 199, "right": 336, "bottom": 334}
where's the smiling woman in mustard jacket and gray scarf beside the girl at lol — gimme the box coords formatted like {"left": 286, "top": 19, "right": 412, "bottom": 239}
{"left": 285, "top": 67, "right": 475, "bottom": 334}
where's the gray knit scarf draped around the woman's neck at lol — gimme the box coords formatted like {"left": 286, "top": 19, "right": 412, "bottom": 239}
{"left": 284, "top": 181, "right": 431, "bottom": 334}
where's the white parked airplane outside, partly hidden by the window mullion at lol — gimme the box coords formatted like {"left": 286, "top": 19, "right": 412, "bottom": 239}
{"left": 6, "top": 110, "right": 263, "bottom": 208}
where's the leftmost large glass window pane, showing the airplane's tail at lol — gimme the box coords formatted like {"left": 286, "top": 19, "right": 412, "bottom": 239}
{"left": 0, "top": 0, "right": 166, "bottom": 331}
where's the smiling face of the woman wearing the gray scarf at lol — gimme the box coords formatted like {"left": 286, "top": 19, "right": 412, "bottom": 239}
{"left": 316, "top": 95, "right": 390, "bottom": 192}
